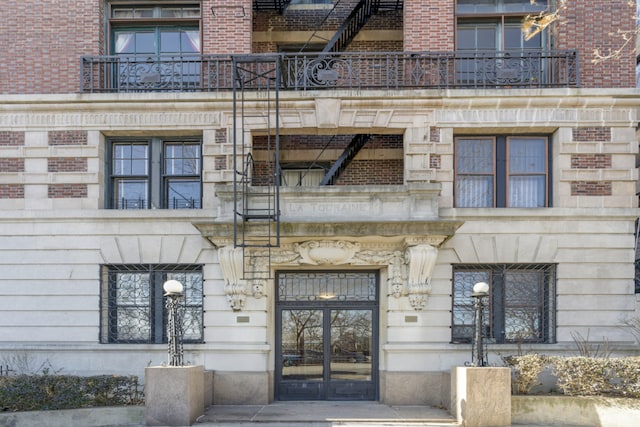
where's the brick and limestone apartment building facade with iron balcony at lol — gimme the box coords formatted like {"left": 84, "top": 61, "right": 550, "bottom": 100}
{"left": 0, "top": 0, "right": 640, "bottom": 406}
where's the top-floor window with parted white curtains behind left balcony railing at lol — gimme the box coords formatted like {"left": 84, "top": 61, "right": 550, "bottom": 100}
{"left": 109, "top": 3, "right": 201, "bottom": 90}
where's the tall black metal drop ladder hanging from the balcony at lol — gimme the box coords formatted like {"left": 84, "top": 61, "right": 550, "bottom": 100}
{"left": 233, "top": 55, "right": 281, "bottom": 280}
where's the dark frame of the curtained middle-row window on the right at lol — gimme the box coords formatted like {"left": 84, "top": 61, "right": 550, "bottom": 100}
{"left": 453, "top": 134, "right": 553, "bottom": 209}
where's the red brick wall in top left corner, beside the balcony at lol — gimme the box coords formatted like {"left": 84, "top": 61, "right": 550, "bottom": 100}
{"left": 0, "top": 0, "right": 102, "bottom": 94}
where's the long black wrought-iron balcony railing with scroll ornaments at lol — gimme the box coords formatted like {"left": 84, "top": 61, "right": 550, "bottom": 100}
{"left": 80, "top": 51, "right": 580, "bottom": 93}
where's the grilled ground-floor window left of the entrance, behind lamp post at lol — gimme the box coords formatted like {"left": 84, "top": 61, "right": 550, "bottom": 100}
{"left": 100, "top": 265, "right": 203, "bottom": 344}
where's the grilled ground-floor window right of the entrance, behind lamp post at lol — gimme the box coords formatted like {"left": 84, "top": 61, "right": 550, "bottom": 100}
{"left": 451, "top": 264, "right": 556, "bottom": 343}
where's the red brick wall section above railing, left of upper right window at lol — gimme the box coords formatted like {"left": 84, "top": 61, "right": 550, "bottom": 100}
{"left": 404, "top": 0, "right": 455, "bottom": 52}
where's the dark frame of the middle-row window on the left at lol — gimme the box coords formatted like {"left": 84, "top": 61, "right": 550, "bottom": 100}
{"left": 105, "top": 137, "right": 203, "bottom": 209}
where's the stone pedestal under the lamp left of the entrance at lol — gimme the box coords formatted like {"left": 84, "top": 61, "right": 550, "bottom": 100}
{"left": 144, "top": 366, "right": 205, "bottom": 426}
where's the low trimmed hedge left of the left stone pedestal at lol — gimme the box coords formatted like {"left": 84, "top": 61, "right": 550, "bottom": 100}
{"left": 0, "top": 374, "right": 143, "bottom": 411}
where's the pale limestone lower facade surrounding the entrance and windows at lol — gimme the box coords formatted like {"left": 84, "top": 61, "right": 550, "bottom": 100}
{"left": 0, "top": 89, "right": 640, "bottom": 404}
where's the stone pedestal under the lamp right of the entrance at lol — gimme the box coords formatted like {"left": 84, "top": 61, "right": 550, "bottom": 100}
{"left": 451, "top": 366, "right": 511, "bottom": 427}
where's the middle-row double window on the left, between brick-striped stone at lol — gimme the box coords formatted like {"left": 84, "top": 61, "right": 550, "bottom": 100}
{"left": 107, "top": 138, "right": 202, "bottom": 209}
